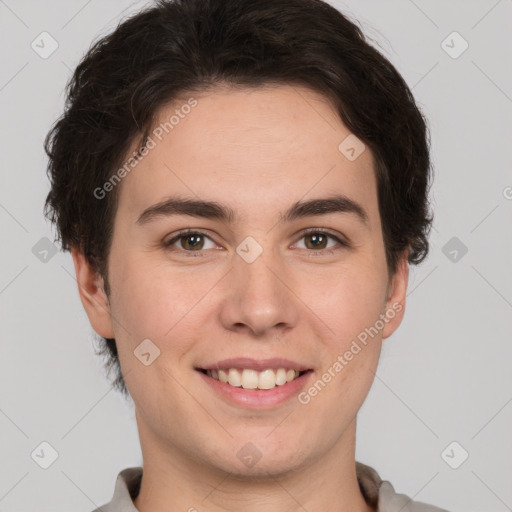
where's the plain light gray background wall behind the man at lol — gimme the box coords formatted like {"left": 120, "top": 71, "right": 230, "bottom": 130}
{"left": 0, "top": 0, "right": 512, "bottom": 512}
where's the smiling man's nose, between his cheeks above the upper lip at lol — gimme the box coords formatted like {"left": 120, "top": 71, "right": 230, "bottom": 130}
{"left": 220, "top": 243, "right": 300, "bottom": 337}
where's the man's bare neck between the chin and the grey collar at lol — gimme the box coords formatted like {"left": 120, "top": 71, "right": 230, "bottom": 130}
{"left": 134, "top": 420, "right": 374, "bottom": 512}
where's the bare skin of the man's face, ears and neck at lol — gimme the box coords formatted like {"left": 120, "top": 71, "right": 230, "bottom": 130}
{"left": 72, "top": 86, "right": 408, "bottom": 512}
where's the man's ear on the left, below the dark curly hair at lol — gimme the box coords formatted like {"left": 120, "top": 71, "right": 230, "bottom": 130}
{"left": 71, "top": 247, "right": 115, "bottom": 338}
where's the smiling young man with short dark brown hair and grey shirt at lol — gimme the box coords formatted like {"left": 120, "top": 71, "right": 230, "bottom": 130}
{"left": 46, "top": 0, "right": 452, "bottom": 512}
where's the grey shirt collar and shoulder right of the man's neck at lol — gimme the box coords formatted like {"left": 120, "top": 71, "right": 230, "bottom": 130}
{"left": 356, "top": 461, "right": 448, "bottom": 512}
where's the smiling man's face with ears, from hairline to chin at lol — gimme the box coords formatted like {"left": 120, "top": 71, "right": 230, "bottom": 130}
{"left": 74, "top": 86, "right": 407, "bottom": 476}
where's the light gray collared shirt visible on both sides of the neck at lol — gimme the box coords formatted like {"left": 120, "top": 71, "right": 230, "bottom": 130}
{"left": 93, "top": 461, "right": 448, "bottom": 512}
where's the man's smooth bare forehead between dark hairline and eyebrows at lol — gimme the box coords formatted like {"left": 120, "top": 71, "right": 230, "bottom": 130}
{"left": 118, "top": 85, "right": 376, "bottom": 224}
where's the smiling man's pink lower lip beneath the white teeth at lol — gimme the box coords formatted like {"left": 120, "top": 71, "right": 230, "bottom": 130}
{"left": 196, "top": 370, "right": 313, "bottom": 409}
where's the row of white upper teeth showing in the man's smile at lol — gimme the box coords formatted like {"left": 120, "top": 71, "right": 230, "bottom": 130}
{"left": 206, "top": 368, "right": 299, "bottom": 389}
